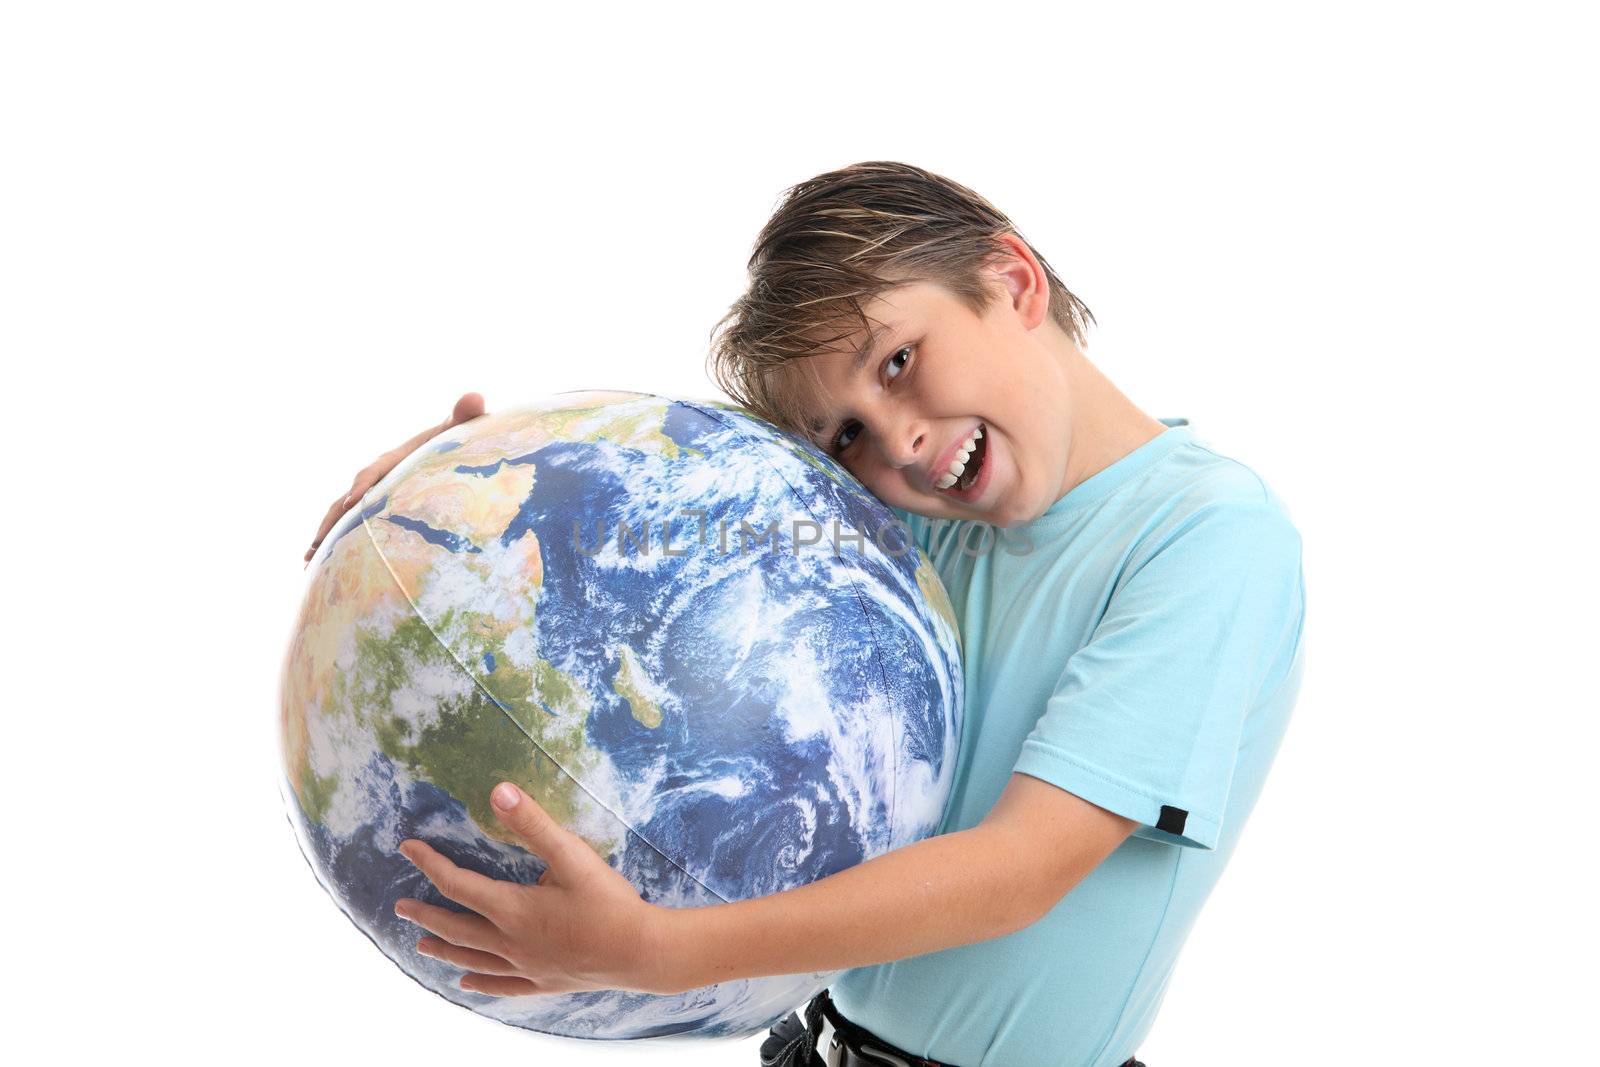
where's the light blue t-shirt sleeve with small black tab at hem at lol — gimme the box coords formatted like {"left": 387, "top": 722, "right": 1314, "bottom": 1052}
{"left": 1014, "top": 502, "right": 1304, "bottom": 848}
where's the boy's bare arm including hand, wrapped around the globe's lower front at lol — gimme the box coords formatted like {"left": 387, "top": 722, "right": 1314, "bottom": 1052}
{"left": 395, "top": 774, "right": 1139, "bottom": 997}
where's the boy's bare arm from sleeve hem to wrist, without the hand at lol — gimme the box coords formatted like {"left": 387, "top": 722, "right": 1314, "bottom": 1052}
{"left": 650, "top": 774, "right": 1139, "bottom": 993}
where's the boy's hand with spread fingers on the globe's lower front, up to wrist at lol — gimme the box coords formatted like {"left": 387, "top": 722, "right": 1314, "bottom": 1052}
{"left": 395, "top": 782, "right": 664, "bottom": 997}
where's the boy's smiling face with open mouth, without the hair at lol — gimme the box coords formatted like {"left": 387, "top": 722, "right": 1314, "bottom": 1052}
{"left": 796, "top": 257, "right": 1072, "bottom": 526}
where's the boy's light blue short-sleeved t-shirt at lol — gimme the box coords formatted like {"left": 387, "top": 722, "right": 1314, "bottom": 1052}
{"left": 830, "top": 419, "right": 1304, "bottom": 1067}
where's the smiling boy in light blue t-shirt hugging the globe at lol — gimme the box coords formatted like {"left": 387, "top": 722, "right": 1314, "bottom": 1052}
{"left": 314, "top": 163, "right": 1304, "bottom": 1067}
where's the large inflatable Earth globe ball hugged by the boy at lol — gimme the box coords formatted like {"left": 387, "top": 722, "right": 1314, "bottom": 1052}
{"left": 280, "top": 392, "right": 962, "bottom": 1038}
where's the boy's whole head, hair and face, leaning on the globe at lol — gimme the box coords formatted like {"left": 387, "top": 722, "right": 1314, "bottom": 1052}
{"left": 709, "top": 162, "right": 1094, "bottom": 526}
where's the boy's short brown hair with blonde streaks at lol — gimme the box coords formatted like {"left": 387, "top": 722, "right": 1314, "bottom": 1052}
{"left": 707, "top": 162, "right": 1094, "bottom": 437}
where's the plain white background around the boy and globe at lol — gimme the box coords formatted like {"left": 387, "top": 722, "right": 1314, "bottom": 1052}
{"left": 0, "top": 2, "right": 1600, "bottom": 1067}
